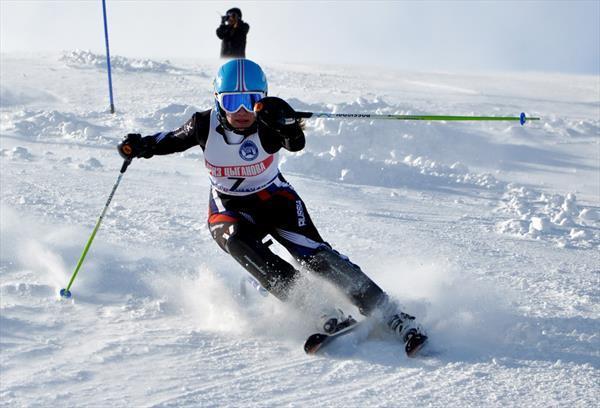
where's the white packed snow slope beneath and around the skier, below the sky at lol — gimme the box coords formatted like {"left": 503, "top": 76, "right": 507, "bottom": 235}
{"left": 0, "top": 51, "right": 600, "bottom": 407}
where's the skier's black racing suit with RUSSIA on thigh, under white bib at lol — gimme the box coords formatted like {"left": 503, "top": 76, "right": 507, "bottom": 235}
{"left": 139, "top": 110, "right": 387, "bottom": 314}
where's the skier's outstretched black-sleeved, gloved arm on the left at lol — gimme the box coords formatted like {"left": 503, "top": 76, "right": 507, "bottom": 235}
{"left": 118, "top": 110, "right": 211, "bottom": 159}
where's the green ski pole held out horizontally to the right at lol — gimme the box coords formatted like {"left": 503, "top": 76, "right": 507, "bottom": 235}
{"left": 296, "top": 112, "right": 540, "bottom": 125}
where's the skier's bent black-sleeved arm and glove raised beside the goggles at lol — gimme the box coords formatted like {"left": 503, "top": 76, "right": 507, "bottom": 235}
{"left": 254, "top": 96, "right": 306, "bottom": 154}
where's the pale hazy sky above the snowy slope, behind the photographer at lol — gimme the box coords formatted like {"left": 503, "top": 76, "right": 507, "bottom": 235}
{"left": 0, "top": 0, "right": 600, "bottom": 75}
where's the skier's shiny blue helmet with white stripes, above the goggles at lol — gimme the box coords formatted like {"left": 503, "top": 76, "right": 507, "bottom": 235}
{"left": 213, "top": 58, "right": 268, "bottom": 123}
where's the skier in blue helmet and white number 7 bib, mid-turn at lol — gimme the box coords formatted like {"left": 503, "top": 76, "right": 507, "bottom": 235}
{"left": 118, "top": 59, "right": 427, "bottom": 355}
